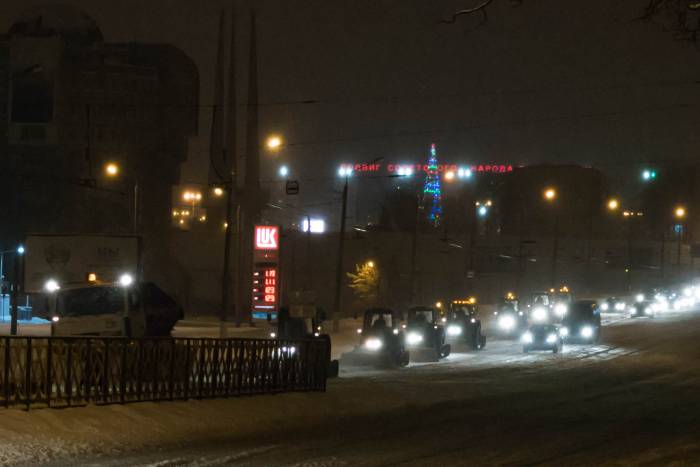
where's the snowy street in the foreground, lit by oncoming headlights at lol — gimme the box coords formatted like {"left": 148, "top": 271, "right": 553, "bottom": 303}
{"left": 21, "top": 312, "right": 700, "bottom": 466}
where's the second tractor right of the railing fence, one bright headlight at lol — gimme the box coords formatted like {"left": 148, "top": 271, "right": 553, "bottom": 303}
{"left": 405, "top": 305, "right": 451, "bottom": 360}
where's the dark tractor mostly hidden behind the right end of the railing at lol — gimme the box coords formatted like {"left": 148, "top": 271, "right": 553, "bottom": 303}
{"left": 270, "top": 305, "right": 339, "bottom": 377}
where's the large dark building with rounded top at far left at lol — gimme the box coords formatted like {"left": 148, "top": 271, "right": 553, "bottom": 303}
{"left": 0, "top": 6, "right": 199, "bottom": 288}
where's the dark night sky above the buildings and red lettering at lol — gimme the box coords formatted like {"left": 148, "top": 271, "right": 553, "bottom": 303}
{"left": 0, "top": 0, "right": 700, "bottom": 221}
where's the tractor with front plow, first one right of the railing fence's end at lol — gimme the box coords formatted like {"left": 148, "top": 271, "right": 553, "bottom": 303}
{"left": 342, "top": 307, "right": 409, "bottom": 367}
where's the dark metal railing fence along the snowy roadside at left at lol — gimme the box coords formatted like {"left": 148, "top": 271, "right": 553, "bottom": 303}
{"left": 0, "top": 337, "right": 328, "bottom": 409}
